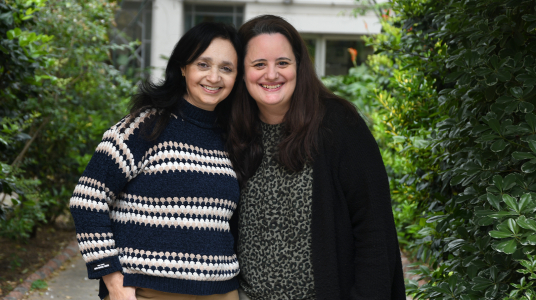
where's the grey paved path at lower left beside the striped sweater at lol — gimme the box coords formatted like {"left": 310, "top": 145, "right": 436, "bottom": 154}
{"left": 28, "top": 254, "right": 99, "bottom": 300}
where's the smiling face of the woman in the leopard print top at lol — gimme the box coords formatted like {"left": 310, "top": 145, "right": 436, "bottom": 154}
{"left": 244, "top": 33, "right": 297, "bottom": 119}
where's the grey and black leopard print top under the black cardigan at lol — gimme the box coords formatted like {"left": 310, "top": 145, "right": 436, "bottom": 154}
{"left": 237, "top": 123, "right": 315, "bottom": 300}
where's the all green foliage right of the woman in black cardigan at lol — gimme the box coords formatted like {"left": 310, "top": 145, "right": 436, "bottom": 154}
{"left": 326, "top": 0, "right": 536, "bottom": 299}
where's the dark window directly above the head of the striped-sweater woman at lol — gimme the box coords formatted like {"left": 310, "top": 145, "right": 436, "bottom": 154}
{"left": 184, "top": 4, "right": 244, "bottom": 31}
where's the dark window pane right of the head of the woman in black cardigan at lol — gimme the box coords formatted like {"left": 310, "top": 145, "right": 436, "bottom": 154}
{"left": 326, "top": 40, "right": 374, "bottom": 75}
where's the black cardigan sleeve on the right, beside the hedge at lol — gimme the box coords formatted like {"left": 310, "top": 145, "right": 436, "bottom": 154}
{"left": 338, "top": 112, "right": 406, "bottom": 300}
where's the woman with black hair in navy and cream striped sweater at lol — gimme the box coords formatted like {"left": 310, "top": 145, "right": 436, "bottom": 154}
{"left": 70, "top": 23, "right": 242, "bottom": 300}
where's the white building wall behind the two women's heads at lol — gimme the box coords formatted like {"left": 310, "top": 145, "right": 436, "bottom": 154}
{"left": 151, "top": 0, "right": 388, "bottom": 79}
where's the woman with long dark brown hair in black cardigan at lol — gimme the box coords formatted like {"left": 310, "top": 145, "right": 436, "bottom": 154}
{"left": 227, "top": 15, "right": 405, "bottom": 300}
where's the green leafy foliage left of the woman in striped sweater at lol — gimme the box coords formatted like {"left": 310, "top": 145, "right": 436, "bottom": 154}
{"left": 0, "top": 0, "right": 134, "bottom": 239}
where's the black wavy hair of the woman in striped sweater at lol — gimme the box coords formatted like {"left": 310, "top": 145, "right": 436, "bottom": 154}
{"left": 130, "top": 22, "right": 243, "bottom": 140}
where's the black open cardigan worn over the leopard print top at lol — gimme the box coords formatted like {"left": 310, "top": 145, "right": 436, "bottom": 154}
{"left": 231, "top": 100, "right": 406, "bottom": 300}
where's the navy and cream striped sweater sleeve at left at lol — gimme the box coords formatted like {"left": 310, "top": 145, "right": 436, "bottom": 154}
{"left": 70, "top": 120, "right": 134, "bottom": 279}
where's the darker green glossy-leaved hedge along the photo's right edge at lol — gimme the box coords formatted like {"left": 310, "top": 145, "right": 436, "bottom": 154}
{"left": 411, "top": 0, "right": 536, "bottom": 299}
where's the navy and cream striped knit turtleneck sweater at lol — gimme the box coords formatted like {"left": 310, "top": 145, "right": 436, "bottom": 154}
{"left": 70, "top": 100, "right": 240, "bottom": 297}
